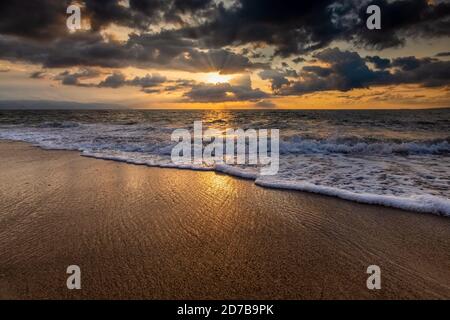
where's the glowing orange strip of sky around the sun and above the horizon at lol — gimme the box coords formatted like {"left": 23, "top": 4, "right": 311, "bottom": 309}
{"left": 0, "top": 61, "right": 450, "bottom": 110}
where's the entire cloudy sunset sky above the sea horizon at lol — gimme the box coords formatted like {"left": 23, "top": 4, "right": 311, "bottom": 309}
{"left": 0, "top": 0, "right": 450, "bottom": 109}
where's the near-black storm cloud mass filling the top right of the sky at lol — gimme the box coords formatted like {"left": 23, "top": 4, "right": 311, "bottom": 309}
{"left": 178, "top": 0, "right": 450, "bottom": 57}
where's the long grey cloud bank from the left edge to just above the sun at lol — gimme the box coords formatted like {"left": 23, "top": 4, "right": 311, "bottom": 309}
{"left": 0, "top": 32, "right": 266, "bottom": 73}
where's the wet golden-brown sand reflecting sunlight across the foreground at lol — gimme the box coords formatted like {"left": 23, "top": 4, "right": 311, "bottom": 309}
{"left": 0, "top": 142, "right": 450, "bottom": 299}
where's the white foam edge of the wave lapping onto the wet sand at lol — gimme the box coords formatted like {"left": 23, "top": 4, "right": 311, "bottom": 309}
{"left": 0, "top": 139, "right": 450, "bottom": 217}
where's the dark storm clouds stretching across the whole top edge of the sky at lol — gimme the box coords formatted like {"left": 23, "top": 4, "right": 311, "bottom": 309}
{"left": 0, "top": 0, "right": 450, "bottom": 57}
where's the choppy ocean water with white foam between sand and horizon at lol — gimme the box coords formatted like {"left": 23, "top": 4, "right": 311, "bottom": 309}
{"left": 0, "top": 109, "right": 450, "bottom": 216}
